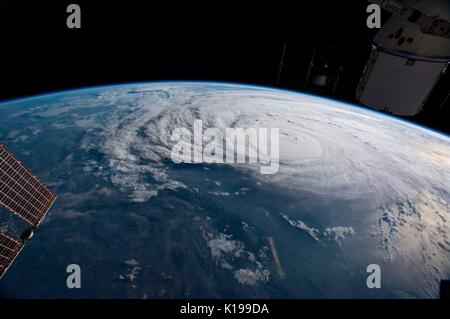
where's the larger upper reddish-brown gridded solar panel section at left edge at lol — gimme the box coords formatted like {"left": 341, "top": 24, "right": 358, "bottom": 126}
{"left": 0, "top": 144, "right": 56, "bottom": 227}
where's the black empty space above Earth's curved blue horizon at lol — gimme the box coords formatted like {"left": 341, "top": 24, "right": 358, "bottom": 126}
{"left": 0, "top": 0, "right": 450, "bottom": 133}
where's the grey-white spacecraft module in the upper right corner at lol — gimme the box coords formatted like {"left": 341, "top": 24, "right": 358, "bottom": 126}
{"left": 356, "top": 0, "right": 450, "bottom": 116}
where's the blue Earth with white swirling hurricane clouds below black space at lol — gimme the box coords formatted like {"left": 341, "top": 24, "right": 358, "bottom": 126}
{"left": 0, "top": 82, "right": 450, "bottom": 298}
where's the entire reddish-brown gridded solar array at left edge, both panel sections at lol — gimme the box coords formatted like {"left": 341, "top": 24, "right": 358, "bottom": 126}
{"left": 0, "top": 144, "right": 56, "bottom": 278}
